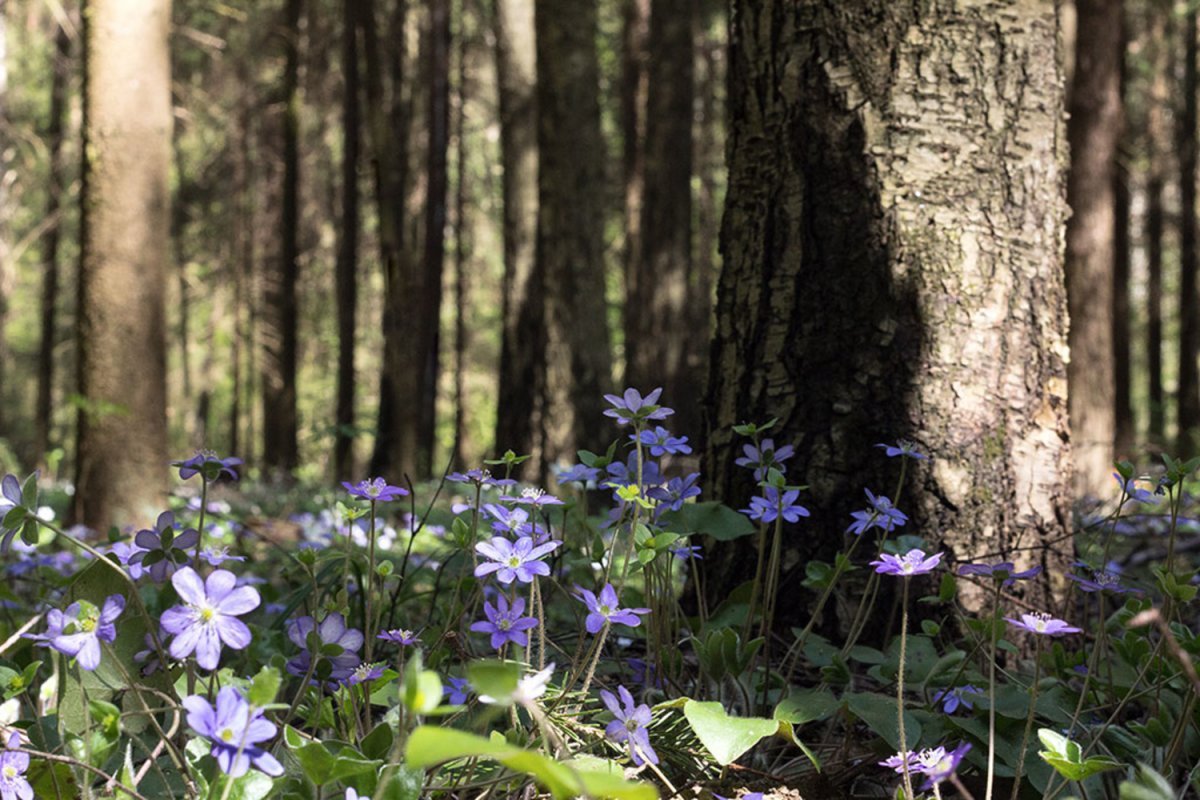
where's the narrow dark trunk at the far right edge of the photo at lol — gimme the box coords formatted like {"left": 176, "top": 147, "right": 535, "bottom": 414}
{"left": 1175, "top": 10, "right": 1200, "bottom": 458}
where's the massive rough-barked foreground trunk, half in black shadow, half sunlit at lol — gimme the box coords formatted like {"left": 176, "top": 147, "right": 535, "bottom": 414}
{"left": 700, "top": 0, "right": 1069, "bottom": 622}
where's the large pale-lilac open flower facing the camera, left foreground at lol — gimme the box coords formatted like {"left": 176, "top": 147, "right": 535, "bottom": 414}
{"left": 162, "top": 566, "right": 262, "bottom": 669}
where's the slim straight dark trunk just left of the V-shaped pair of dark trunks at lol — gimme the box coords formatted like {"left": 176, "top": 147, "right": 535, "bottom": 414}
{"left": 334, "top": 0, "right": 361, "bottom": 480}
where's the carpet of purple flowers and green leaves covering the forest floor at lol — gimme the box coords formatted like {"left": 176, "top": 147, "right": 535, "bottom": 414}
{"left": 0, "top": 390, "right": 1200, "bottom": 800}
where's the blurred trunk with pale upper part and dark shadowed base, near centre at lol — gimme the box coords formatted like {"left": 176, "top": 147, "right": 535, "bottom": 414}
{"left": 493, "top": 0, "right": 545, "bottom": 464}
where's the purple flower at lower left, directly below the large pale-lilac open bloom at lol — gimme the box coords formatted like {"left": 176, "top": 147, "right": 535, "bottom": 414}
{"left": 184, "top": 686, "right": 283, "bottom": 777}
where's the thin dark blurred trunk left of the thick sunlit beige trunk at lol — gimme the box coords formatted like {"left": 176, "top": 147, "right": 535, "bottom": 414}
{"left": 34, "top": 24, "right": 71, "bottom": 465}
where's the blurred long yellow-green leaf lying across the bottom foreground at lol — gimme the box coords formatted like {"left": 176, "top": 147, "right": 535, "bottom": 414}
{"left": 404, "top": 726, "right": 658, "bottom": 800}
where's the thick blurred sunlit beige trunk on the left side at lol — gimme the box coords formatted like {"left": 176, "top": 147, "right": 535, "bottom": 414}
{"left": 74, "top": 0, "right": 172, "bottom": 530}
